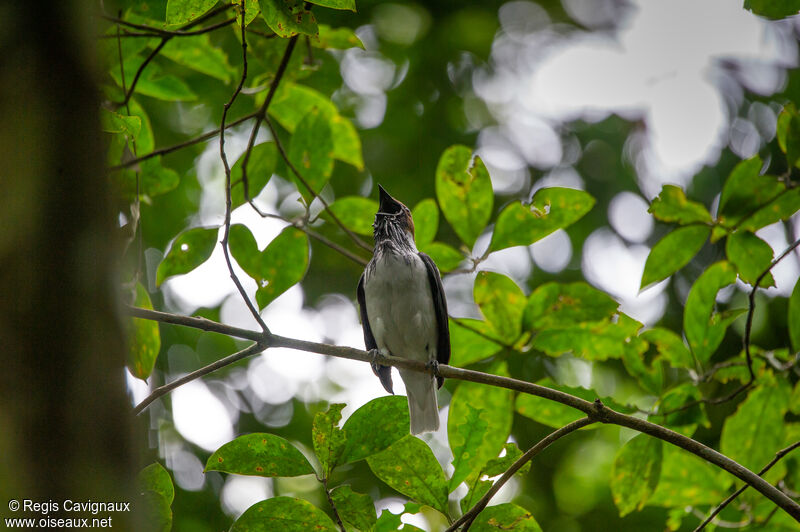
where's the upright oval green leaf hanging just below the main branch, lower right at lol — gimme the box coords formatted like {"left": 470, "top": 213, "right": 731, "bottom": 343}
{"left": 611, "top": 434, "right": 663, "bottom": 517}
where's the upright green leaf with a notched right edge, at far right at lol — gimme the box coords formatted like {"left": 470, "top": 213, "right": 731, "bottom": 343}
{"left": 683, "top": 261, "right": 738, "bottom": 362}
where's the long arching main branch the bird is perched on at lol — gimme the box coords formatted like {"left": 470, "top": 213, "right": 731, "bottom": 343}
{"left": 123, "top": 309, "right": 800, "bottom": 522}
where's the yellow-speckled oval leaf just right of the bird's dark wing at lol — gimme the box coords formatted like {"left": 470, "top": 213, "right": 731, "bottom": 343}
{"left": 473, "top": 271, "right": 527, "bottom": 343}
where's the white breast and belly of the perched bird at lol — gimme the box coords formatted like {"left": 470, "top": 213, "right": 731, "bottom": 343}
{"left": 364, "top": 253, "right": 438, "bottom": 362}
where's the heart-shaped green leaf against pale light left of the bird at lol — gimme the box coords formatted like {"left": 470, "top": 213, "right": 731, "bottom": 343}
{"left": 228, "top": 224, "right": 308, "bottom": 308}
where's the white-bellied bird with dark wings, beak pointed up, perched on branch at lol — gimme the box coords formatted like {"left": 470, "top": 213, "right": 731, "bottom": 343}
{"left": 357, "top": 185, "right": 450, "bottom": 435}
